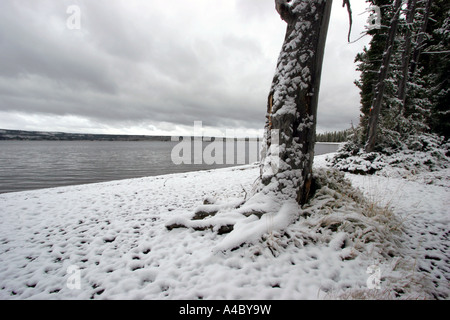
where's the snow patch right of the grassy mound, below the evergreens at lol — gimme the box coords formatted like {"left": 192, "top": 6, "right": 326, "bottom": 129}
{"left": 352, "top": 168, "right": 450, "bottom": 299}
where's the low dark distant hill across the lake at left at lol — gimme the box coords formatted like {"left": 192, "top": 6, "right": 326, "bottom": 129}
{"left": 0, "top": 129, "right": 170, "bottom": 141}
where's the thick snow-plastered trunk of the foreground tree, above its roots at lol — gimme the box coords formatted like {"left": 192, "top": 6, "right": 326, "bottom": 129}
{"left": 261, "top": 0, "right": 332, "bottom": 205}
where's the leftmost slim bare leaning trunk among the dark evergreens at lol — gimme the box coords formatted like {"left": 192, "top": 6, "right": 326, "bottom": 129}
{"left": 365, "top": 0, "right": 402, "bottom": 152}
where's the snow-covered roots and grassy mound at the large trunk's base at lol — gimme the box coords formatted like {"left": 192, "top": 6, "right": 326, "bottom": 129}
{"left": 166, "top": 169, "right": 402, "bottom": 259}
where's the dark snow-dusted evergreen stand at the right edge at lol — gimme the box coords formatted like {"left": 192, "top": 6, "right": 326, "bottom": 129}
{"left": 353, "top": 0, "right": 450, "bottom": 151}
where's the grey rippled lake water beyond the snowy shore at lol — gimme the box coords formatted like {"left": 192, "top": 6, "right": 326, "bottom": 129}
{"left": 0, "top": 141, "right": 338, "bottom": 193}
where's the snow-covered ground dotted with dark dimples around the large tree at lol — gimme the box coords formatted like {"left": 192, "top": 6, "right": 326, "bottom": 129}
{"left": 0, "top": 156, "right": 450, "bottom": 299}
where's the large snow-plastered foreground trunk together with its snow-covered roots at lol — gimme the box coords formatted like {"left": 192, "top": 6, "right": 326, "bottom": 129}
{"left": 166, "top": 0, "right": 332, "bottom": 251}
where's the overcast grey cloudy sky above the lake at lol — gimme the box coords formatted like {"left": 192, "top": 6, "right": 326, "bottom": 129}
{"left": 0, "top": 0, "right": 369, "bottom": 136}
